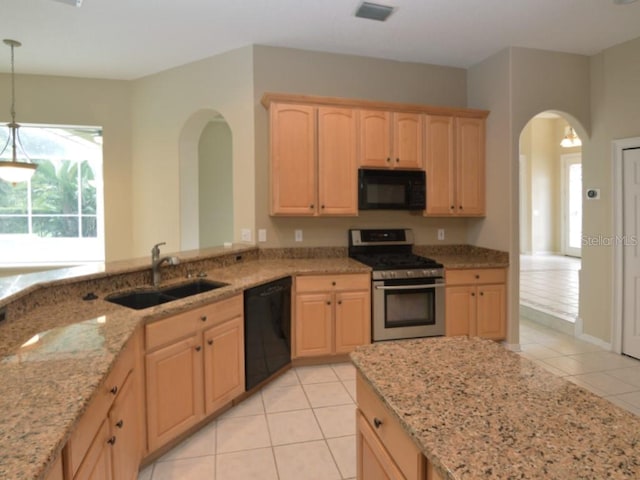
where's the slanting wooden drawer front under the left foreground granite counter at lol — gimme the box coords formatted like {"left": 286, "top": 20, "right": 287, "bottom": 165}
{"left": 66, "top": 339, "right": 136, "bottom": 476}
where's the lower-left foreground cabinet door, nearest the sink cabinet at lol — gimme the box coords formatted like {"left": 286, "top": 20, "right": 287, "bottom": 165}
{"left": 109, "top": 372, "right": 142, "bottom": 480}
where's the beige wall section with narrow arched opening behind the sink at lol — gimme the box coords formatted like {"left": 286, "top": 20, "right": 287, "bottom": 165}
{"left": 132, "top": 47, "right": 256, "bottom": 256}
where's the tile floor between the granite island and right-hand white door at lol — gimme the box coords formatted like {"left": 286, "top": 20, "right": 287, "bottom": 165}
{"left": 520, "top": 319, "right": 640, "bottom": 415}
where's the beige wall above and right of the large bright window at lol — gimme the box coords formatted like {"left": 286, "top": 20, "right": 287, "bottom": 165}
{"left": 0, "top": 74, "right": 133, "bottom": 261}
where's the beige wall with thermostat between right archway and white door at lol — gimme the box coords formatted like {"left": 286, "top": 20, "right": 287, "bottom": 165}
{"left": 580, "top": 38, "right": 640, "bottom": 342}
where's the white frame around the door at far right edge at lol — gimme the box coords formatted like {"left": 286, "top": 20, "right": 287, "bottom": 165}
{"left": 611, "top": 137, "right": 640, "bottom": 353}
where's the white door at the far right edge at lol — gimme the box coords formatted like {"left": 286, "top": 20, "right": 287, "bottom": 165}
{"left": 616, "top": 148, "right": 640, "bottom": 358}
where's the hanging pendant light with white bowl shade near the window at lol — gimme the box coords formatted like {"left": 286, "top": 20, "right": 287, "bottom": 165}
{"left": 0, "top": 39, "right": 38, "bottom": 183}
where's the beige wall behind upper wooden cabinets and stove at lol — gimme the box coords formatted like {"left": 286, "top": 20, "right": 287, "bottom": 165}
{"left": 254, "top": 46, "right": 467, "bottom": 246}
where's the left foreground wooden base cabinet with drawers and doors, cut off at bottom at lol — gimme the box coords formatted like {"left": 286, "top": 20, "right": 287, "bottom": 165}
{"left": 64, "top": 333, "right": 143, "bottom": 480}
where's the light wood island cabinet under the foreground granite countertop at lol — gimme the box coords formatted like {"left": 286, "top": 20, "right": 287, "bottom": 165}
{"left": 356, "top": 374, "right": 442, "bottom": 480}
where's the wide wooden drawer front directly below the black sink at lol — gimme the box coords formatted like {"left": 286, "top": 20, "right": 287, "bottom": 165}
{"left": 145, "top": 295, "right": 242, "bottom": 350}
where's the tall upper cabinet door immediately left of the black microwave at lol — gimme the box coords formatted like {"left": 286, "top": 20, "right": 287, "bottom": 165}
{"left": 318, "top": 107, "right": 358, "bottom": 216}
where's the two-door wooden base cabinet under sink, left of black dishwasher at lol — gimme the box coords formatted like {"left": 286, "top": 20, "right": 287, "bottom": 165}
{"left": 145, "top": 295, "right": 244, "bottom": 451}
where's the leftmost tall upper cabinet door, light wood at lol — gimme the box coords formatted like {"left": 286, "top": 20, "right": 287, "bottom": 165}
{"left": 269, "top": 103, "right": 317, "bottom": 215}
